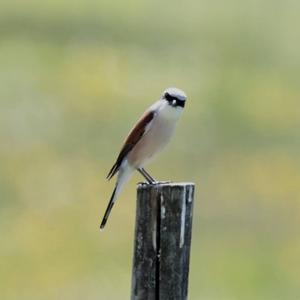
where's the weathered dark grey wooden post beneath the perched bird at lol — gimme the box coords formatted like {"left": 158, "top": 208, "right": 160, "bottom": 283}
{"left": 131, "top": 183, "right": 194, "bottom": 300}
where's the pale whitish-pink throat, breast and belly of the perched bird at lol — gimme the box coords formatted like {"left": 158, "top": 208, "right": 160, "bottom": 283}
{"left": 128, "top": 102, "right": 182, "bottom": 168}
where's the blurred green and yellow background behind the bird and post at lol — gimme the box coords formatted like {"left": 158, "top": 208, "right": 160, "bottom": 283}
{"left": 0, "top": 0, "right": 300, "bottom": 300}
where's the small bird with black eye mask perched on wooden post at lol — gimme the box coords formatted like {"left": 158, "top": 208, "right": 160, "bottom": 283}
{"left": 100, "top": 87, "right": 187, "bottom": 230}
